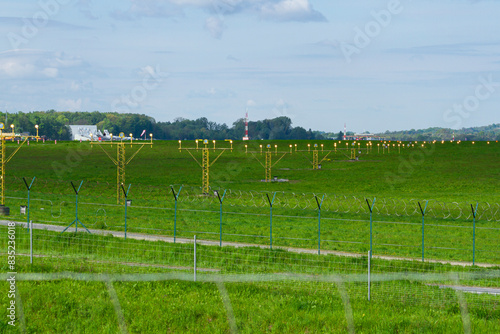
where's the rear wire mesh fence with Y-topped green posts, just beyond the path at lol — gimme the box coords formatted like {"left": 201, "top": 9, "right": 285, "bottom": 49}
{"left": 1, "top": 178, "right": 500, "bottom": 264}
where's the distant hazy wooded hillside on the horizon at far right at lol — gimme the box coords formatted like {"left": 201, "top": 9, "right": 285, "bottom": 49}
{"left": 380, "top": 123, "right": 500, "bottom": 141}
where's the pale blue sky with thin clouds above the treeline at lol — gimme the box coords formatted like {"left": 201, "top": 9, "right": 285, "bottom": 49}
{"left": 0, "top": 0, "right": 500, "bottom": 136}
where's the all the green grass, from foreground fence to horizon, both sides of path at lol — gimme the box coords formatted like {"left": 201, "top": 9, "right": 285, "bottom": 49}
{"left": 0, "top": 141, "right": 500, "bottom": 333}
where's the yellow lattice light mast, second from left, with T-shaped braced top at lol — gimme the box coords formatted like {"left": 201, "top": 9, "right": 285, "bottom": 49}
{"left": 90, "top": 132, "right": 153, "bottom": 204}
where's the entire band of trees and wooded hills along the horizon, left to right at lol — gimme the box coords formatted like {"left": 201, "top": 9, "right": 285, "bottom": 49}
{"left": 0, "top": 110, "right": 500, "bottom": 141}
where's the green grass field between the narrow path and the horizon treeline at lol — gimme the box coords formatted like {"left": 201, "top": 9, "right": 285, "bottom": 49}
{"left": 6, "top": 141, "right": 500, "bottom": 264}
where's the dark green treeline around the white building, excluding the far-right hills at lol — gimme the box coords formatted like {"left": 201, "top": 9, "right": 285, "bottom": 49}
{"left": 0, "top": 110, "right": 323, "bottom": 140}
